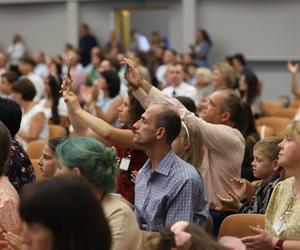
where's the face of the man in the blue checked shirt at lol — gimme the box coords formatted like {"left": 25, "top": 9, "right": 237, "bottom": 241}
{"left": 133, "top": 105, "right": 159, "bottom": 148}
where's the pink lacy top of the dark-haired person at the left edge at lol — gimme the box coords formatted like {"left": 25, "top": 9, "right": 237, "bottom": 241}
{"left": 0, "top": 176, "right": 21, "bottom": 239}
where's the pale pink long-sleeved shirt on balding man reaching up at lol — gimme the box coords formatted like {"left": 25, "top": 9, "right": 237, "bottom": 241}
{"left": 134, "top": 87, "right": 245, "bottom": 209}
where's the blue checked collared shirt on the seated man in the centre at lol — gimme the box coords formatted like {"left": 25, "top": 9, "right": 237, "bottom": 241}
{"left": 135, "top": 150, "right": 208, "bottom": 231}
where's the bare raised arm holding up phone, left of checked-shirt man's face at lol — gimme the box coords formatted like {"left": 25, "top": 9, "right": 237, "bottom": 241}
{"left": 63, "top": 76, "right": 142, "bottom": 149}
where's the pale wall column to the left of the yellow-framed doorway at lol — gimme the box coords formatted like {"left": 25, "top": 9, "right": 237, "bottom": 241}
{"left": 66, "top": 0, "right": 79, "bottom": 47}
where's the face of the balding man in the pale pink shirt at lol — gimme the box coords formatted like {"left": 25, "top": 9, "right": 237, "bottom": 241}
{"left": 201, "top": 91, "right": 225, "bottom": 124}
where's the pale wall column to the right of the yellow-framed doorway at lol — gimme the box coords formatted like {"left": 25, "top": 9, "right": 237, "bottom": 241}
{"left": 181, "top": 0, "right": 197, "bottom": 52}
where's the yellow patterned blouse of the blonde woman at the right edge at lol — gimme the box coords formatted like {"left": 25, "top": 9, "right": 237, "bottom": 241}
{"left": 265, "top": 177, "right": 300, "bottom": 240}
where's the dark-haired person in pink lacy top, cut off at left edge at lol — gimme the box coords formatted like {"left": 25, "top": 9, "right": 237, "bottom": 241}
{"left": 0, "top": 122, "right": 21, "bottom": 242}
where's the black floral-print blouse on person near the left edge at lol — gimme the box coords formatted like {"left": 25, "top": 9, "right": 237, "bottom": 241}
{"left": 5, "top": 139, "right": 35, "bottom": 193}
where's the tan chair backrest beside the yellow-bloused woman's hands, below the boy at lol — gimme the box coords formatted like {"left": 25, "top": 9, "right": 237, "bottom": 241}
{"left": 218, "top": 214, "right": 265, "bottom": 238}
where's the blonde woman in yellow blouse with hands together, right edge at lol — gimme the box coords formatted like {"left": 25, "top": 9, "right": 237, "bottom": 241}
{"left": 243, "top": 122, "right": 300, "bottom": 250}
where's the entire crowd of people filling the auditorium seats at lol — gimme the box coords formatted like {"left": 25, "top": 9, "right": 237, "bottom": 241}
{"left": 0, "top": 24, "right": 300, "bottom": 250}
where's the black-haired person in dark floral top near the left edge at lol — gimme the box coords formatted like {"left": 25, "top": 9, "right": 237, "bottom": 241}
{"left": 0, "top": 98, "right": 35, "bottom": 193}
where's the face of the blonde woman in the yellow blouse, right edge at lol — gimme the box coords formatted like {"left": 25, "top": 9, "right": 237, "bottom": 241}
{"left": 278, "top": 133, "right": 300, "bottom": 170}
